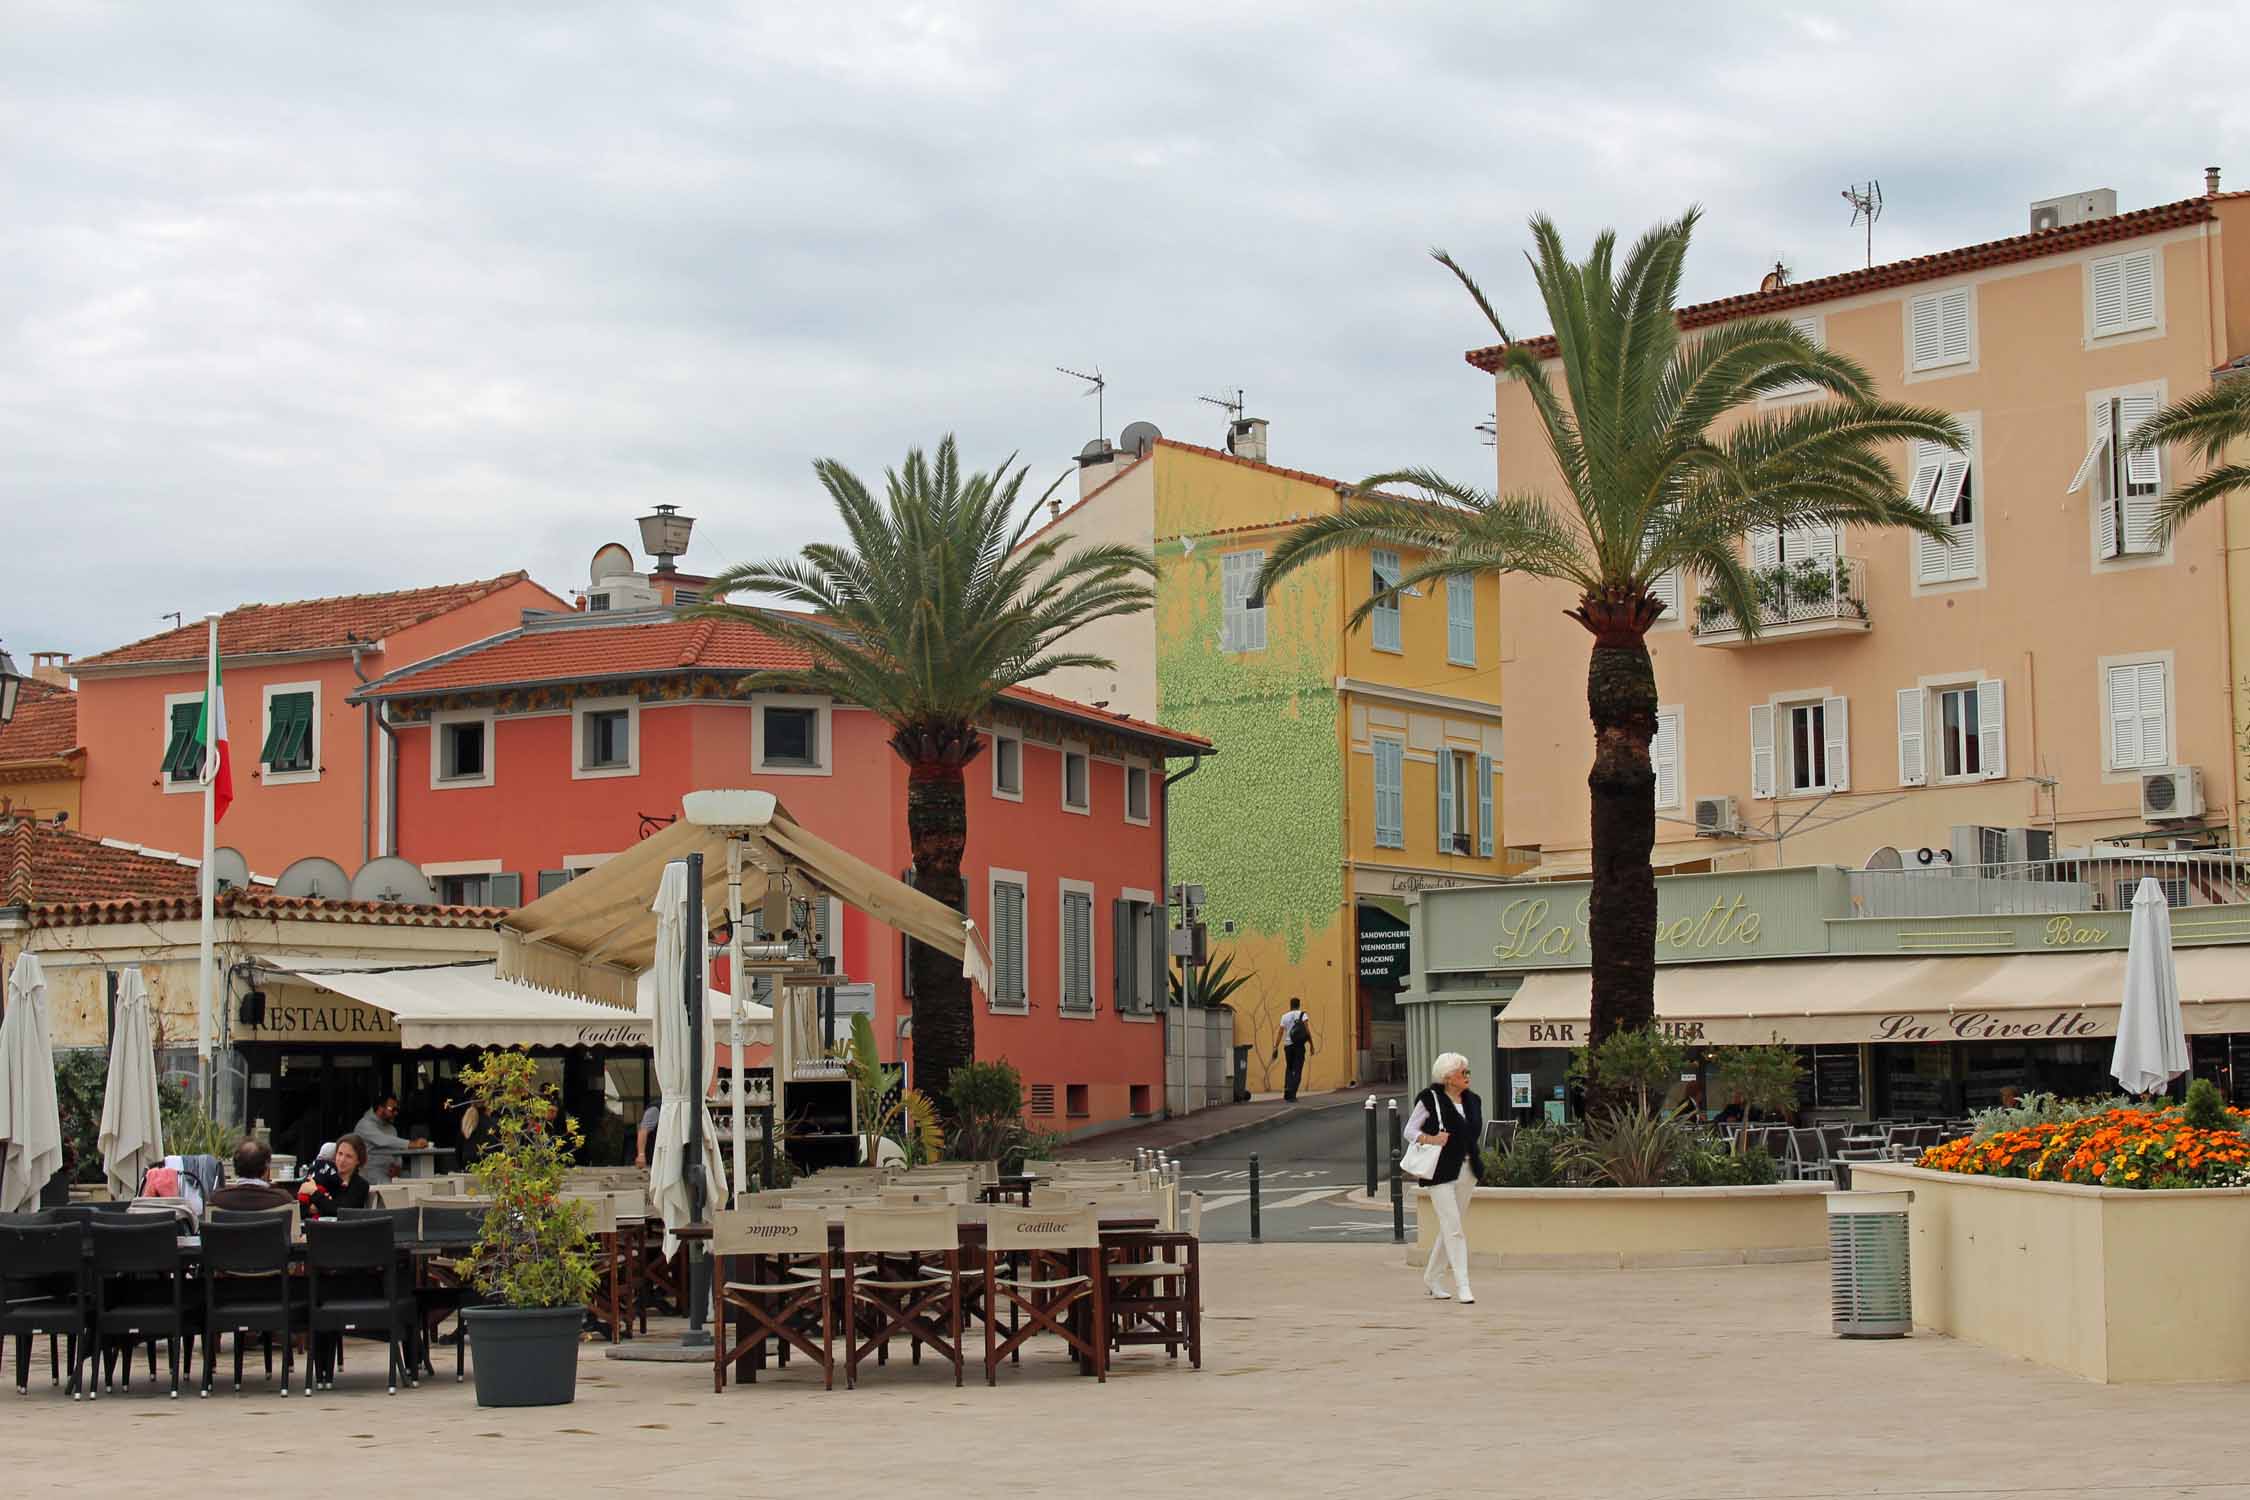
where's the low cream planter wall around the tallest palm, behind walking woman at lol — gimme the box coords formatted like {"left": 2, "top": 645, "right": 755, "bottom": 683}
{"left": 1415, "top": 1183, "right": 1827, "bottom": 1271}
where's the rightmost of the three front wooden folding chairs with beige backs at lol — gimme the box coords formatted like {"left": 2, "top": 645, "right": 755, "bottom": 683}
{"left": 983, "top": 1208, "right": 1109, "bottom": 1385}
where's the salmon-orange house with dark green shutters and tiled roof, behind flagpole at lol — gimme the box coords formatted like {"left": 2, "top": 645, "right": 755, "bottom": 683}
{"left": 72, "top": 573, "right": 567, "bottom": 895}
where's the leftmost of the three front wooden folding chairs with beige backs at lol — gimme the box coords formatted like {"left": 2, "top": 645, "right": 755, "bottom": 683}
{"left": 711, "top": 1194, "right": 837, "bottom": 1392}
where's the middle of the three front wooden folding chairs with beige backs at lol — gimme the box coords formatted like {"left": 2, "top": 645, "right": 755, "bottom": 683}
{"left": 844, "top": 1203, "right": 961, "bottom": 1388}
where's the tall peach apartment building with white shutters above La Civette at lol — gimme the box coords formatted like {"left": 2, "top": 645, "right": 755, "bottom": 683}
{"left": 1469, "top": 182, "right": 2250, "bottom": 868}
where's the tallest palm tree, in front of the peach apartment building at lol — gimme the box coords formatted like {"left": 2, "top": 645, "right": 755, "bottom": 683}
{"left": 1260, "top": 211, "right": 1964, "bottom": 1043}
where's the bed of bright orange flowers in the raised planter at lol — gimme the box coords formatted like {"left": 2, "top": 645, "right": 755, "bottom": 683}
{"left": 1917, "top": 1106, "right": 2250, "bottom": 1187}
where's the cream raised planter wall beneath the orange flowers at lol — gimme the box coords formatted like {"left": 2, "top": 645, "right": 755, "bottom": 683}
{"left": 1852, "top": 1165, "right": 2250, "bottom": 1383}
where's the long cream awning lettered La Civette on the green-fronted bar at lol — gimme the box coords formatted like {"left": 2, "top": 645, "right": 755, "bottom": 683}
{"left": 1496, "top": 947, "right": 2250, "bottom": 1048}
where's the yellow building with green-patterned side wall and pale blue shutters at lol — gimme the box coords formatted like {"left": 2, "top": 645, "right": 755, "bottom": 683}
{"left": 1042, "top": 418, "right": 1523, "bottom": 1088}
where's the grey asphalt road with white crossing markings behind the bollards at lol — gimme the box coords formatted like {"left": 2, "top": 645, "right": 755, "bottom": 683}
{"left": 1181, "top": 1093, "right": 1404, "bottom": 1244}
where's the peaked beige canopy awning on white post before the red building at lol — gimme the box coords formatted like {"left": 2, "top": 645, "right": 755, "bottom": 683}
{"left": 500, "top": 792, "right": 992, "bottom": 1010}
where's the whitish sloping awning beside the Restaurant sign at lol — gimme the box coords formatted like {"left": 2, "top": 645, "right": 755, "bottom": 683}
{"left": 279, "top": 963, "right": 774, "bottom": 1050}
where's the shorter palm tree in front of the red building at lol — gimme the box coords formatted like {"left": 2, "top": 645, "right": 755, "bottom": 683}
{"left": 689, "top": 436, "right": 1157, "bottom": 1095}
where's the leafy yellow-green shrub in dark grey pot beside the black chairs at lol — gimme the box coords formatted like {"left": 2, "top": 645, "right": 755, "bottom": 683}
{"left": 461, "top": 1052, "right": 596, "bottom": 1406}
